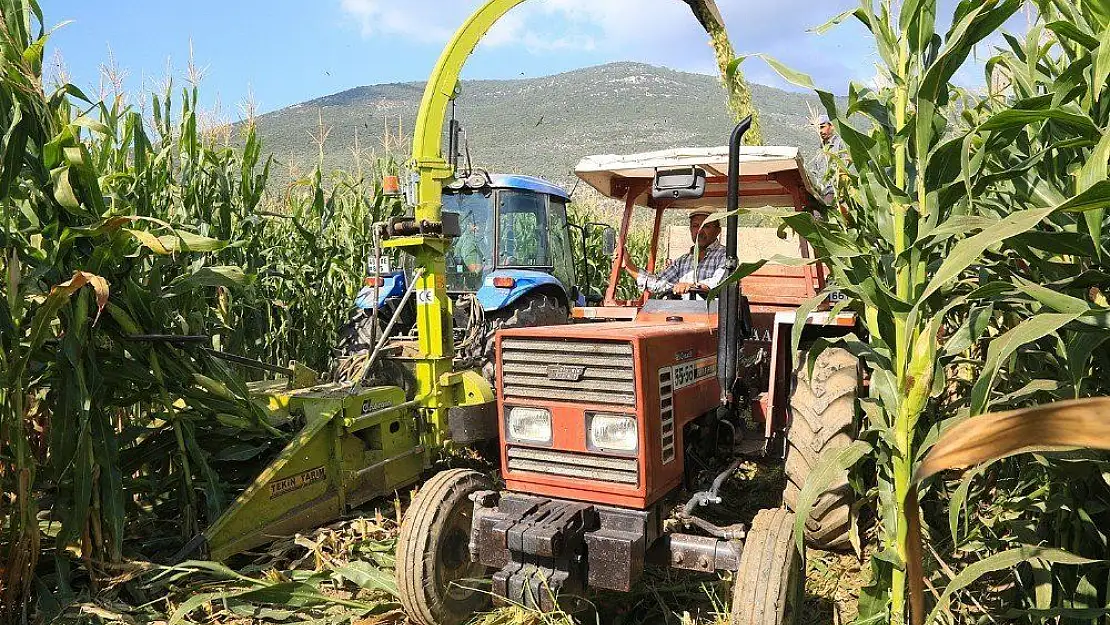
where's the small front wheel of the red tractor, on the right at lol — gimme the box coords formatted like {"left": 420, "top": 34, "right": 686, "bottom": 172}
{"left": 731, "top": 508, "right": 806, "bottom": 625}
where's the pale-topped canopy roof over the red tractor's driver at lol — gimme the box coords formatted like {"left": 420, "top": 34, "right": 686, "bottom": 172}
{"left": 575, "top": 145, "right": 820, "bottom": 209}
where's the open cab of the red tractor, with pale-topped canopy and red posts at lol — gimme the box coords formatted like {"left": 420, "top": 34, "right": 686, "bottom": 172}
{"left": 573, "top": 145, "right": 826, "bottom": 333}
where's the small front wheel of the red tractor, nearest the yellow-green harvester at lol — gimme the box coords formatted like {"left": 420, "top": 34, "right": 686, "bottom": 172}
{"left": 396, "top": 468, "right": 494, "bottom": 625}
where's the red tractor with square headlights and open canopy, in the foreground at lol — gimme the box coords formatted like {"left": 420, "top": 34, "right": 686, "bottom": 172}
{"left": 397, "top": 123, "right": 860, "bottom": 625}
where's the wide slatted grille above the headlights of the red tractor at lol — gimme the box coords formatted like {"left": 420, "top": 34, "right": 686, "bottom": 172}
{"left": 501, "top": 339, "right": 636, "bottom": 406}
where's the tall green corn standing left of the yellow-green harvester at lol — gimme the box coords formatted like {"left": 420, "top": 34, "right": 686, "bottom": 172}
{"left": 0, "top": 0, "right": 397, "bottom": 621}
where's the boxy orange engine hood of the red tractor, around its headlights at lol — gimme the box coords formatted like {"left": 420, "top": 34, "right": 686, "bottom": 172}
{"left": 497, "top": 317, "right": 720, "bottom": 508}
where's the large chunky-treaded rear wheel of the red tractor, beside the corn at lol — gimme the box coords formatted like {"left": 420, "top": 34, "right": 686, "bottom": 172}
{"left": 783, "top": 347, "right": 860, "bottom": 551}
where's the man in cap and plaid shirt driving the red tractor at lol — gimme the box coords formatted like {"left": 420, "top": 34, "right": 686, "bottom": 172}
{"left": 623, "top": 210, "right": 728, "bottom": 295}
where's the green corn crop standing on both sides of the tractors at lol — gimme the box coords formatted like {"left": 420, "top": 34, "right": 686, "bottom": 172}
{"left": 0, "top": 0, "right": 1110, "bottom": 625}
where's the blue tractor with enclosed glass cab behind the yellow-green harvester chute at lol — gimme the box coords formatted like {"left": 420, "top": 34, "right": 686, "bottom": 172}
{"left": 340, "top": 171, "right": 585, "bottom": 380}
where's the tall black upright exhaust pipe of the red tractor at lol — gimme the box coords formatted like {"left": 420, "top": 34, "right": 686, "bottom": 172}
{"left": 717, "top": 115, "right": 751, "bottom": 406}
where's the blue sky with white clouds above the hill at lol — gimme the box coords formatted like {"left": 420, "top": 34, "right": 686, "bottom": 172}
{"left": 43, "top": 0, "right": 1025, "bottom": 119}
